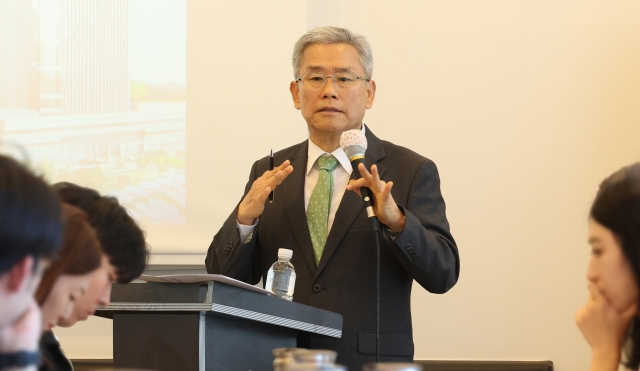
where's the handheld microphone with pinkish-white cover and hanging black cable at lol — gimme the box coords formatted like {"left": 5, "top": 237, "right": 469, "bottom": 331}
{"left": 340, "top": 129, "right": 380, "bottom": 363}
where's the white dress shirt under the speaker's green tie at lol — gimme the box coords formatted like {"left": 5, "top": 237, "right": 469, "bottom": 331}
{"left": 236, "top": 124, "right": 365, "bottom": 243}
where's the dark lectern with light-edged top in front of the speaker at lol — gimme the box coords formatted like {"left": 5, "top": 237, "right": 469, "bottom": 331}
{"left": 96, "top": 281, "right": 342, "bottom": 371}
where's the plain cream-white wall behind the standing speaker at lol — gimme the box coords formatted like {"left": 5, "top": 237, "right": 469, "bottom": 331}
{"left": 57, "top": 0, "right": 640, "bottom": 371}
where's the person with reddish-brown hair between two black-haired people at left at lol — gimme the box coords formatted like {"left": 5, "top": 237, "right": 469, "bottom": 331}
{"left": 36, "top": 204, "right": 104, "bottom": 371}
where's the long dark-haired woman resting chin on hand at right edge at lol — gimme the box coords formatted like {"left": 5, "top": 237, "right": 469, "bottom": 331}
{"left": 576, "top": 163, "right": 640, "bottom": 371}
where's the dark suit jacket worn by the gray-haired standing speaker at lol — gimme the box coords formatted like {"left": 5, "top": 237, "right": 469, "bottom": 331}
{"left": 206, "top": 127, "right": 460, "bottom": 370}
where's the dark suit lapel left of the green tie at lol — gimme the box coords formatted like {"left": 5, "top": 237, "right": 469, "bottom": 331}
{"left": 278, "top": 142, "right": 317, "bottom": 274}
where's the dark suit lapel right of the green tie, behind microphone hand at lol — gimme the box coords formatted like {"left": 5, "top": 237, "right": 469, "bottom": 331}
{"left": 314, "top": 126, "right": 387, "bottom": 277}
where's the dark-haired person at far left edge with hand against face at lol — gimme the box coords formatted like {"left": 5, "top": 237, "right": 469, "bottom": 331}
{"left": 0, "top": 155, "right": 63, "bottom": 370}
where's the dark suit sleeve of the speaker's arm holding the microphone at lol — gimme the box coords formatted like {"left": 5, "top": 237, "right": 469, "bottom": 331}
{"left": 385, "top": 159, "right": 460, "bottom": 293}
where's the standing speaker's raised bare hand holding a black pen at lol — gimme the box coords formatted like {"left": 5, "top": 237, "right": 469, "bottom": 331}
{"left": 236, "top": 160, "right": 293, "bottom": 225}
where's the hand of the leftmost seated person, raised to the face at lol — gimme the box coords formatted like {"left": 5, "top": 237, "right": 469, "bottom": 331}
{"left": 0, "top": 300, "right": 42, "bottom": 354}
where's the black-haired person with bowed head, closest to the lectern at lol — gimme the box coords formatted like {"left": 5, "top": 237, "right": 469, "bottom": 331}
{"left": 53, "top": 182, "right": 149, "bottom": 327}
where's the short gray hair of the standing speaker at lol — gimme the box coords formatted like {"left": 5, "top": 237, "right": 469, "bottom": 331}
{"left": 291, "top": 26, "right": 373, "bottom": 80}
